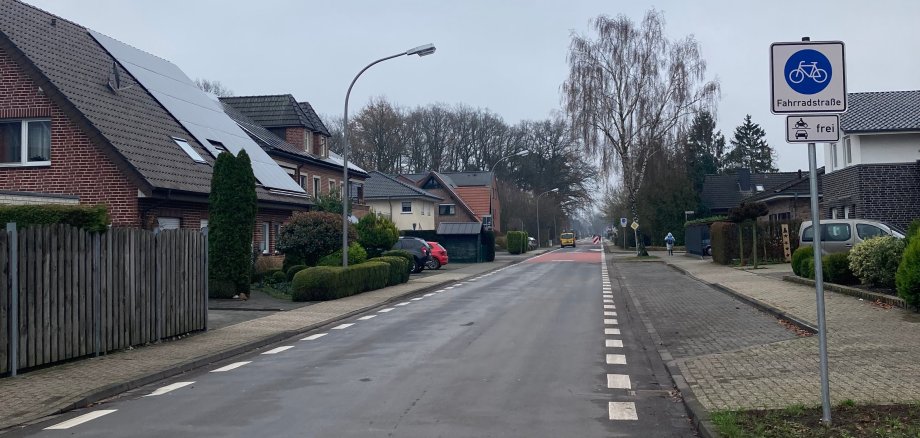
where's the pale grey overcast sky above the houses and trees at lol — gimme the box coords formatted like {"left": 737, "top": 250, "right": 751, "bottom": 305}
{"left": 21, "top": 0, "right": 920, "bottom": 171}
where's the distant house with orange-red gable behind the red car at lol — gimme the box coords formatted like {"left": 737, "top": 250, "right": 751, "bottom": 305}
{"left": 401, "top": 171, "right": 501, "bottom": 231}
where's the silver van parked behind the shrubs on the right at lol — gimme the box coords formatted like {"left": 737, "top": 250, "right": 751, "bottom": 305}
{"left": 799, "top": 219, "right": 906, "bottom": 254}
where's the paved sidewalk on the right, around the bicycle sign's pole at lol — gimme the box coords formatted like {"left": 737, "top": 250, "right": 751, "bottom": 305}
{"left": 651, "top": 252, "right": 920, "bottom": 411}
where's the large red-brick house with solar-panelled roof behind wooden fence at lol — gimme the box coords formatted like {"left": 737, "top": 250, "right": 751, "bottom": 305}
{"left": 0, "top": 0, "right": 311, "bottom": 251}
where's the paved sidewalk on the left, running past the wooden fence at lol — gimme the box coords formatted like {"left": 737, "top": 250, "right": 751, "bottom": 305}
{"left": 0, "top": 249, "right": 546, "bottom": 433}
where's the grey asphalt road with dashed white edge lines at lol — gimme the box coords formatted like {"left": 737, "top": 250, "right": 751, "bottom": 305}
{"left": 14, "top": 245, "right": 693, "bottom": 437}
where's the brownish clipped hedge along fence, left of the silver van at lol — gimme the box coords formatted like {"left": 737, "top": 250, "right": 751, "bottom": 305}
{"left": 709, "top": 220, "right": 802, "bottom": 265}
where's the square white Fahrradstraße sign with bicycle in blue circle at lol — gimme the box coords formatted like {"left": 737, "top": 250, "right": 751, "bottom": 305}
{"left": 770, "top": 41, "right": 847, "bottom": 114}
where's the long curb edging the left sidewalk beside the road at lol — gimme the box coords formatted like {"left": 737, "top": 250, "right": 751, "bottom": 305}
{"left": 0, "top": 251, "right": 550, "bottom": 435}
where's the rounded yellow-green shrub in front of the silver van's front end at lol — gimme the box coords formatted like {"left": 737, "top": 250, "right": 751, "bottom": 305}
{"left": 849, "top": 236, "right": 904, "bottom": 288}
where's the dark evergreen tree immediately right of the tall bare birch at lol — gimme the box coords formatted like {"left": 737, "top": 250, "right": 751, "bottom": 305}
{"left": 684, "top": 111, "right": 725, "bottom": 193}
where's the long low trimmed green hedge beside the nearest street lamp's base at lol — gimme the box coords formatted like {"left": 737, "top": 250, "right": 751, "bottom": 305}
{"left": 291, "top": 260, "right": 390, "bottom": 301}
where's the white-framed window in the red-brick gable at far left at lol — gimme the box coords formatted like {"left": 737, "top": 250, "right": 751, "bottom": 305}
{"left": 0, "top": 120, "right": 51, "bottom": 166}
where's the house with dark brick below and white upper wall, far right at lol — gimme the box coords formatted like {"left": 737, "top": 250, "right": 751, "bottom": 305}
{"left": 822, "top": 90, "right": 920, "bottom": 228}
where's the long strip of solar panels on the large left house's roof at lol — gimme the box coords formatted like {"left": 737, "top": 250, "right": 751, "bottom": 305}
{"left": 89, "top": 30, "right": 304, "bottom": 193}
